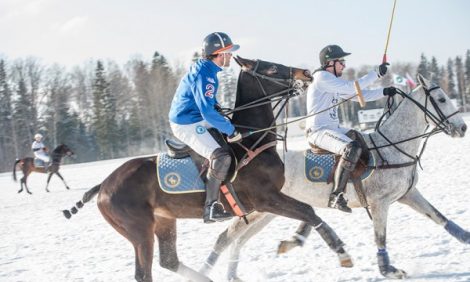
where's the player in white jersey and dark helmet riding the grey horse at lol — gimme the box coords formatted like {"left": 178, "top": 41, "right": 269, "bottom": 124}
{"left": 306, "top": 45, "right": 396, "bottom": 212}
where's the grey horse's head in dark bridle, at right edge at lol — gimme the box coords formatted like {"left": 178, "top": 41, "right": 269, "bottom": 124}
{"left": 418, "top": 74, "right": 467, "bottom": 137}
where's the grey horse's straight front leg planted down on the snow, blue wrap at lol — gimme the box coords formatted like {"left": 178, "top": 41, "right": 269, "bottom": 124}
{"left": 371, "top": 202, "right": 406, "bottom": 279}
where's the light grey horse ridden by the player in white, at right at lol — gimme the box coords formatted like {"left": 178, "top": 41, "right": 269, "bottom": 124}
{"left": 200, "top": 75, "right": 470, "bottom": 281}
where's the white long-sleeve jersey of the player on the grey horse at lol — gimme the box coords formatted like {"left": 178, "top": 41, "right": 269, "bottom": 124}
{"left": 305, "top": 71, "right": 384, "bottom": 134}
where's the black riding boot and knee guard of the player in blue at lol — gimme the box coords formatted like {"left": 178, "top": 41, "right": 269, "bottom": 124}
{"left": 203, "top": 148, "right": 232, "bottom": 223}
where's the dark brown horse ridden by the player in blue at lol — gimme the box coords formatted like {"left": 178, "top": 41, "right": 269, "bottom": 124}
{"left": 64, "top": 55, "right": 343, "bottom": 281}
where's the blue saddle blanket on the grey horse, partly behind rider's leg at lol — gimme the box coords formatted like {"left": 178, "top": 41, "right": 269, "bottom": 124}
{"left": 304, "top": 150, "right": 375, "bottom": 182}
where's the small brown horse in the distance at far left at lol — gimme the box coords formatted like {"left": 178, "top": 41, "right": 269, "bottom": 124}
{"left": 13, "top": 144, "right": 73, "bottom": 194}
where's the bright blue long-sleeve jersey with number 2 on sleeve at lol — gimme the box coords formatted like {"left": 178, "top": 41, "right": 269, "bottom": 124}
{"left": 169, "top": 59, "right": 235, "bottom": 135}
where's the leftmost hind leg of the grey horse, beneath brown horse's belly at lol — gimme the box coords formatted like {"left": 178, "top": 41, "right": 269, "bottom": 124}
{"left": 199, "top": 211, "right": 267, "bottom": 275}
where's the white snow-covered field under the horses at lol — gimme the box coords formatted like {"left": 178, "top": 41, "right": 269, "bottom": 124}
{"left": 0, "top": 116, "right": 470, "bottom": 282}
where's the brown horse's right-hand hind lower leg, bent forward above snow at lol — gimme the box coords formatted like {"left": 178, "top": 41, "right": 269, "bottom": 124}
{"left": 155, "top": 217, "right": 211, "bottom": 282}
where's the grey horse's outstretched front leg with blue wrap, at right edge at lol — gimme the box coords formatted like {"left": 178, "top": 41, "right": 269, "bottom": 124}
{"left": 399, "top": 188, "right": 470, "bottom": 244}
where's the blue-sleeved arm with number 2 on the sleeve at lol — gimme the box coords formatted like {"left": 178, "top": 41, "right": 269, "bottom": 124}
{"left": 193, "top": 74, "right": 235, "bottom": 135}
